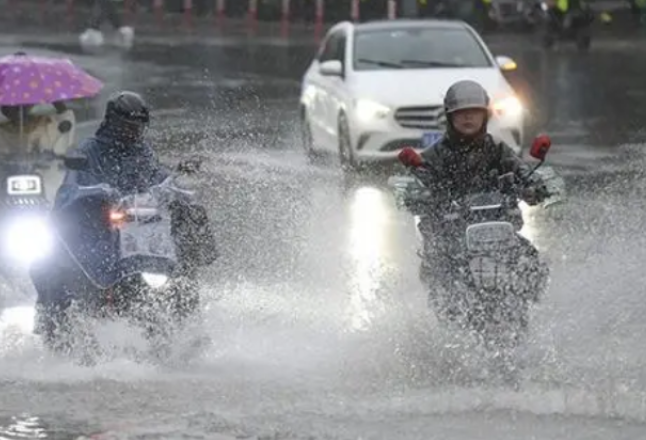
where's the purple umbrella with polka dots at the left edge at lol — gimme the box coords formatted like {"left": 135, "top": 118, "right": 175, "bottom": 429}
{"left": 0, "top": 53, "right": 103, "bottom": 105}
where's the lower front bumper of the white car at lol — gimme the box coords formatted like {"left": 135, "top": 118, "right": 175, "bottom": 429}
{"left": 354, "top": 119, "right": 523, "bottom": 162}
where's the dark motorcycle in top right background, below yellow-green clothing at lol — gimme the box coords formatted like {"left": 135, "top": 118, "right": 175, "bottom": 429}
{"left": 540, "top": 1, "right": 594, "bottom": 51}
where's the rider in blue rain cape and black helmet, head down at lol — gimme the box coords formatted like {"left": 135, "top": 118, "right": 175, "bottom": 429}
{"left": 31, "top": 92, "right": 216, "bottom": 336}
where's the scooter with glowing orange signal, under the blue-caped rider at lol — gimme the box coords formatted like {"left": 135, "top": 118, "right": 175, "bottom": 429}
{"left": 31, "top": 157, "right": 216, "bottom": 358}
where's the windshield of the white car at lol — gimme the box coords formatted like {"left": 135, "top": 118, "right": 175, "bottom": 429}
{"left": 354, "top": 27, "right": 491, "bottom": 70}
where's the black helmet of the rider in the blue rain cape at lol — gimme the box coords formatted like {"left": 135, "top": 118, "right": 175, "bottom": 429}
{"left": 103, "top": 91, "right": 150, "bottom": 143}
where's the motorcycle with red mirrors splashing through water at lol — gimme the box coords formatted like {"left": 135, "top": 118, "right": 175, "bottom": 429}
{"left": 389, "top": 136, "right": 564, "bottom": 349}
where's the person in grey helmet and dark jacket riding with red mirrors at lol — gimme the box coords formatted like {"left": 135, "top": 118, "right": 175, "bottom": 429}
{"left": 409, "top": 81, "right": 547, "bottom": 302}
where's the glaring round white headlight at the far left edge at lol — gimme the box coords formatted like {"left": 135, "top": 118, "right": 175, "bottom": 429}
{"left": 5, "top": 218, "right": 54, "bottom": 264}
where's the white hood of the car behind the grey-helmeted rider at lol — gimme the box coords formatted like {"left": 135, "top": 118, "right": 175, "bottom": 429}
{"left": 351, "top": 67, "right": 512, "bottom": 107}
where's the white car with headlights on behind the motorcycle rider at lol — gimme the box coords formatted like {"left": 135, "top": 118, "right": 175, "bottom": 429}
{"left": 300, "top": 20, "right": 524, "bottom": 167}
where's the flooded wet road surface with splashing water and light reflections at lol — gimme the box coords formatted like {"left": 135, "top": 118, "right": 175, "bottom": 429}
{"left": 0, "top": 31, "right": 646, "bottom": 440}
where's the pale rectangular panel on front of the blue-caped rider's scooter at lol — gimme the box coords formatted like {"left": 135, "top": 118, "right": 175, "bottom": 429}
{"left": 119, "top": 221, "right": 175, "bottom": 260}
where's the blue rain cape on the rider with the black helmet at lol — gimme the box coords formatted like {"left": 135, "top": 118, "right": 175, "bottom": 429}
{"left": 30, "top": 126, "right": 218, "bottom": 308}
